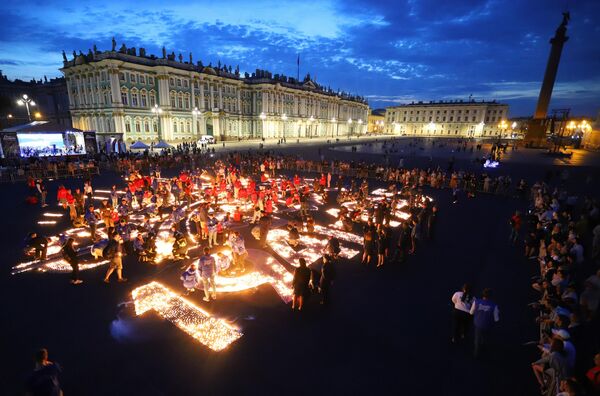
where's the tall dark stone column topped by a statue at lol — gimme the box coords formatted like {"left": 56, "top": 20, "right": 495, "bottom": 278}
{"left": 525, "top": 12, "right": 570, "bottom": 146}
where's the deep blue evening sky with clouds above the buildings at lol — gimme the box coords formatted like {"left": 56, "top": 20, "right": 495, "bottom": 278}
{"left": 0, "top": 0, "right": 600, "bottom": 116}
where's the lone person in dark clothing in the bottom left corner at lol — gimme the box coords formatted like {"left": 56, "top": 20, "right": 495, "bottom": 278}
{"left": 25, "top": 348, "right": 62, "bottom": 396}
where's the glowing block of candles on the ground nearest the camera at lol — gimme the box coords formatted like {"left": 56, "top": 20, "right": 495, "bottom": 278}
{"left": 131, "top": 282, "right": 243, "bottom": 351}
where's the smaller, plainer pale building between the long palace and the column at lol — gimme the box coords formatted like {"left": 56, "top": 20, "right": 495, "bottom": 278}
{"left": 385, "top": 100, "right": 509, "bottom": 137}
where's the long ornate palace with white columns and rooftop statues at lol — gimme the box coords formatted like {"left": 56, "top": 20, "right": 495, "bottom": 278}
{"left": 61, "top": 42, "right": 369, "bottom": 147}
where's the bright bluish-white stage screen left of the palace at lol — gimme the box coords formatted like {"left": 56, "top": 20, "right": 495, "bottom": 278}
{"left": 17, "top": 132, "right": 85, "bottom": 157}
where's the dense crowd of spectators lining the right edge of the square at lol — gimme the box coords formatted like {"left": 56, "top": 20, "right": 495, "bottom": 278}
{"left": 509, "top": 182, "right": 600, "bottom": 396}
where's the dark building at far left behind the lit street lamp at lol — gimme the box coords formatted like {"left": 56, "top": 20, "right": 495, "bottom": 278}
{"left": 0, "top": 71, "right": 71, "bottom": 128}
